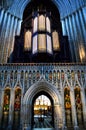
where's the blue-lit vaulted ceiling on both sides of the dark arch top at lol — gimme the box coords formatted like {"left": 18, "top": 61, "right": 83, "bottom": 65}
{"left": 0, "top": 0, "right": 86, "bottom": 18}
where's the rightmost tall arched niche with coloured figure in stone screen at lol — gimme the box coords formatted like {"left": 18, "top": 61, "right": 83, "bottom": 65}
{"left": 74, "top": 86, "right": 83, "bottom": 125}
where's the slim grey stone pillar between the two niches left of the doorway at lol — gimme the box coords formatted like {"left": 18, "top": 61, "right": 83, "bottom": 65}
{"left": 8, "top": 88, "right": 14, "bottom": 127}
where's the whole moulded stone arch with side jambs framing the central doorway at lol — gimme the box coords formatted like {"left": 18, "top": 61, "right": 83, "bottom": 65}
{"left": 23, "top": 81, "right": 63, "bottom": 128}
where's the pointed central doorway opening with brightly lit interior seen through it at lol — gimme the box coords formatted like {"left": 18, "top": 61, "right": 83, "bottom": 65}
{"left": 32, "top": 91, "right": 54, "bottom": 128}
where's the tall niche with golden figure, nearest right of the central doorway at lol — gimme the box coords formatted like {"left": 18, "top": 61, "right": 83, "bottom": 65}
{"left": 64, "top": 87, "right": 72, "bottom": 127}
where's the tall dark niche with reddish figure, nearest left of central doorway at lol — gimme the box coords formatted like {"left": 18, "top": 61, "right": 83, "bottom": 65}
{"left": 13, "top": 87, "right": 21, "bottom": 130}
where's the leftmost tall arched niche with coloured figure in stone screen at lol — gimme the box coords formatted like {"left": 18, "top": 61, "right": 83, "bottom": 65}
{"left": 2, "top": 87, "right": 10, "bottom": 129}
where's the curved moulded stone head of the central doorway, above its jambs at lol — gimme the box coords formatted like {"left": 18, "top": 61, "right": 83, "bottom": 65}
{"left": 23, "top": 81, "right": 62, "bottom": 104}
